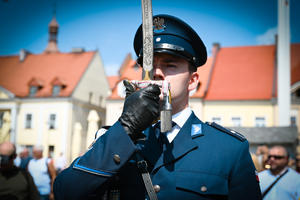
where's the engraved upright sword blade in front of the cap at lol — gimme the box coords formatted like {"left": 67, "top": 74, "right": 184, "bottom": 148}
{"left": 141, "top": 0, "right": 153, "bottom": 80}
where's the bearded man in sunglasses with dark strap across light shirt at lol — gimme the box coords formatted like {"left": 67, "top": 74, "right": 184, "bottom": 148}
{"left": 258, "top": 145, "right": 300, "bottom": 200}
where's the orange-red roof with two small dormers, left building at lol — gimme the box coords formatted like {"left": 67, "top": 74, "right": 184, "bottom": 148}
{"left": 0, "top": 51, "right": 96, "bottom": 97}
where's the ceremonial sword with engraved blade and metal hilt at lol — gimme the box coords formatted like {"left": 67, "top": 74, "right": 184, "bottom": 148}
{"left": 130, "top": 0, "right": 172, "bottom": 133}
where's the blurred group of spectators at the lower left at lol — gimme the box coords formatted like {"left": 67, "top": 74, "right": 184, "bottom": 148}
{"left": 0, "top": 142, "right": 66, "bottom": 200}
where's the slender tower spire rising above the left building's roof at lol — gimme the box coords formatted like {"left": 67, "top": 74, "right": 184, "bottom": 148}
{"left": 44, "top": 4, "right": 59, "bottom": 53}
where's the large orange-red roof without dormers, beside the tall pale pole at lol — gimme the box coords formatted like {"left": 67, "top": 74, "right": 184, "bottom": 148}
{"left": 205, "top": 45, "right": 275, "bottom": 100}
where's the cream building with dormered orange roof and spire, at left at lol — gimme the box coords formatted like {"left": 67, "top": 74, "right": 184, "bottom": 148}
{"left": 0, "top": 13, "right": 109, "bottom": 162}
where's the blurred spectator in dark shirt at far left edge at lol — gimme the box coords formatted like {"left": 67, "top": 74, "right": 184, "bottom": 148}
{"left": 0, "top": 142, "right": 39, "bottom": 200}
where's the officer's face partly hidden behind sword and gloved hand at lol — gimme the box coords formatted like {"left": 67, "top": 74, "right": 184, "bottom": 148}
{"left": 153, "top": 53, "right": 199, "bottom": 114}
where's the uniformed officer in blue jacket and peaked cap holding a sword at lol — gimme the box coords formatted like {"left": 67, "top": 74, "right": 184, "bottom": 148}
{"left": 54, "top": 15, "right": 261, "bottom": 200}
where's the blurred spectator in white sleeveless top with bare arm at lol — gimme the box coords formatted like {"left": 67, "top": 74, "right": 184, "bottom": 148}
{"left": 28, "top": 145, "right": 56, "bottom": 200}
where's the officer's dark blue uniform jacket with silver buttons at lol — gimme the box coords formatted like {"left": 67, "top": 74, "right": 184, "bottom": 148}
{"left": 54, "top": 113, "right": 261, "bottom": 200}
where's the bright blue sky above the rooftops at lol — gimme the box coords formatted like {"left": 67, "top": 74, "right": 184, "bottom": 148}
{"left": 0, "top": 0, "right": 300, "bottom": 75}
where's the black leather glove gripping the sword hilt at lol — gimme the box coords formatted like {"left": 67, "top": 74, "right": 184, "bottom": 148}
{"left": 119, "top": 83, "right": 160, "bottom": 141}
